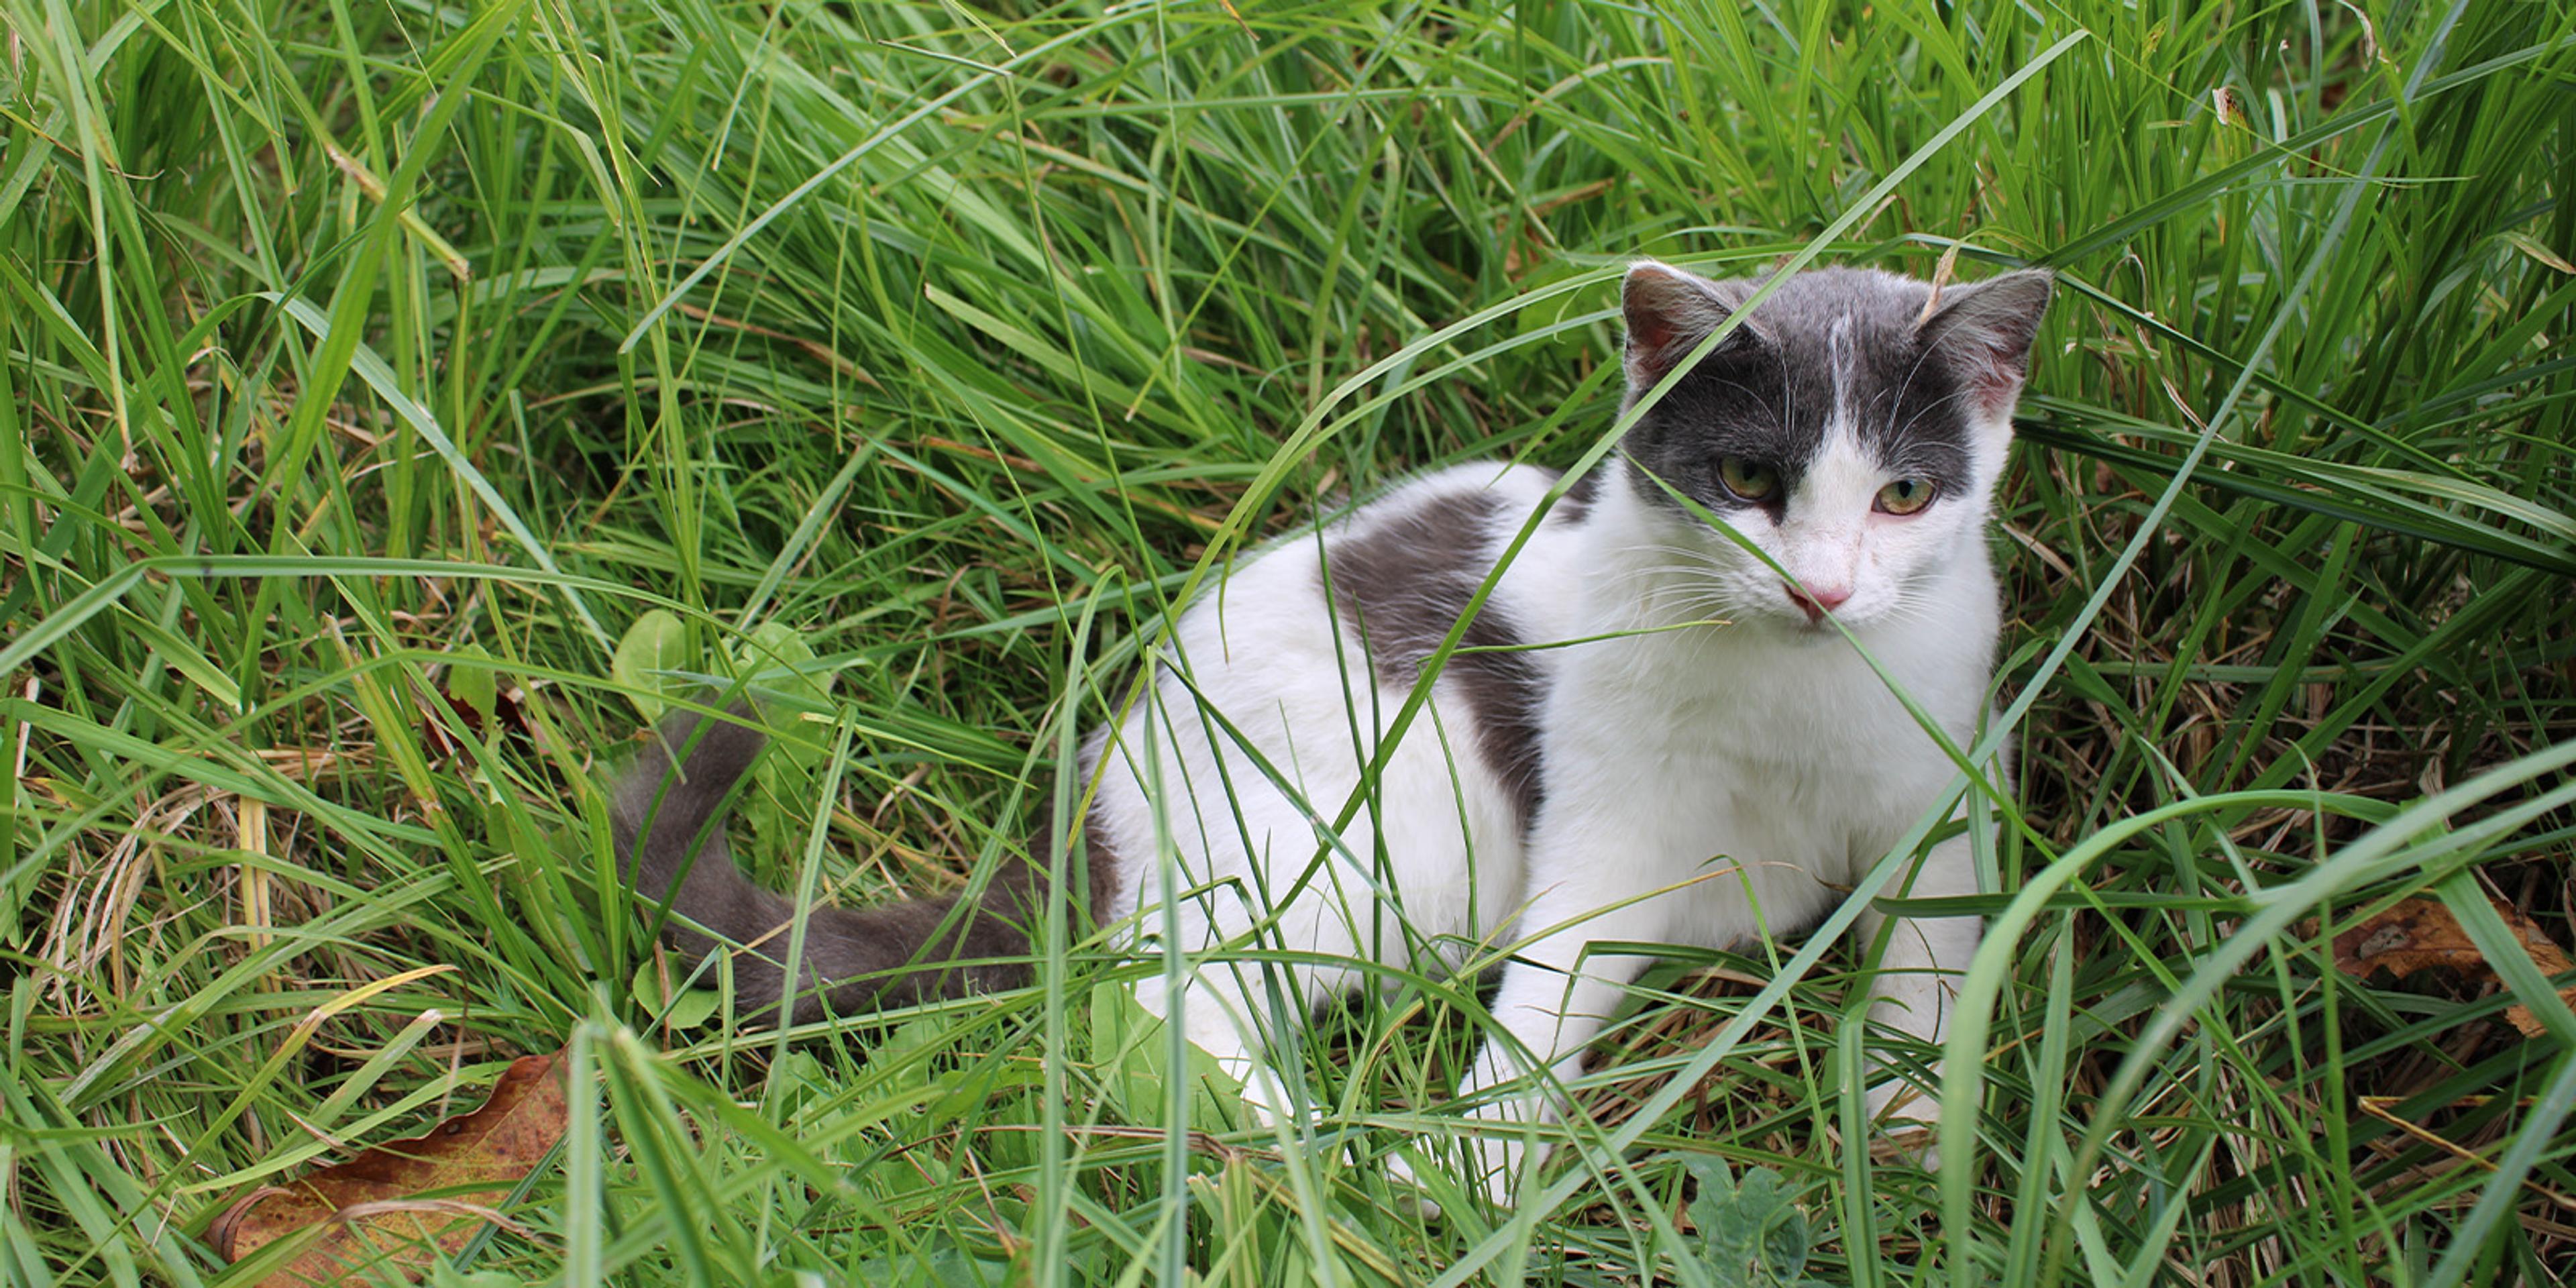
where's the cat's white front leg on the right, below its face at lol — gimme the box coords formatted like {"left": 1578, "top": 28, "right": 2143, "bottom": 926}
{"left": 1858, "top": 835, "right": 1984, "bottom": 1167}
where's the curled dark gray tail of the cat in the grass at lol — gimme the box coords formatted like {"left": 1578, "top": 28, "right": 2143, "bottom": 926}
{"left": 608, "top": 703, "right": 1105, "bottom": 1025}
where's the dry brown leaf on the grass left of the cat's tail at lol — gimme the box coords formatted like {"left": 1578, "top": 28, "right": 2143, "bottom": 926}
{"left": 206, "top": 1054, "right": 567, "bottom": 1288}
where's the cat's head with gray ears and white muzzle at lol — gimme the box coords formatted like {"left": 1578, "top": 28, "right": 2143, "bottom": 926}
{"left": 1620, "top": 260, "right": 2051, "bottom": 634}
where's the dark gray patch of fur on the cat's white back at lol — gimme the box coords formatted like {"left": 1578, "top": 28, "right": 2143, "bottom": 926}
{"left": 1324, "top": 479, "right": 1535, "bottom": 827}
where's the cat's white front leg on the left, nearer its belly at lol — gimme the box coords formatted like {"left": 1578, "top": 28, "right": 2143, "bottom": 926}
{"left": 1396, "top": 876, "right": 1669, "bottom": 1208}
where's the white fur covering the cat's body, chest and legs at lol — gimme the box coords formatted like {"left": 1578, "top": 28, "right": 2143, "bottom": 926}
{"left": 1089, "top": 412, "right": 2009, "bottom": 1200}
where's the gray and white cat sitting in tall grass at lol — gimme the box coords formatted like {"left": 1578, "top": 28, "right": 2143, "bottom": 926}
{"left": 613, "top": 260, "right": 2053, "bottom": 1203}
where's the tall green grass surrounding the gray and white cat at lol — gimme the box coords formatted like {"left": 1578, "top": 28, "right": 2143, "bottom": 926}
{"left": 0, "top": 0, "right": 2576, "bottom": 1288}
